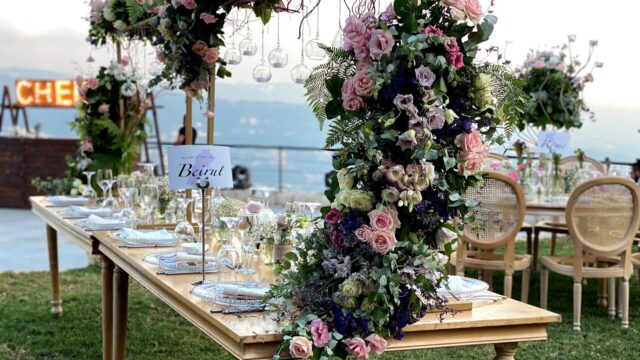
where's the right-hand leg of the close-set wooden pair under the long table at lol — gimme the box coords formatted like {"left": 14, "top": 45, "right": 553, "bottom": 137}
{"left": 113, "top": 266, "right": 129, "bottom": 360}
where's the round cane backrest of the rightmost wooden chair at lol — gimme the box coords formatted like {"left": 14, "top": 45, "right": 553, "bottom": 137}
{"left": 566, "top": 176, "right": 640, "bottom": 256}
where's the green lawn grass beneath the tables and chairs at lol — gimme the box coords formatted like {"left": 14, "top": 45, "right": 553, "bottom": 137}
{"left": 0, "top": 238, "right": 640, "bottom": 360}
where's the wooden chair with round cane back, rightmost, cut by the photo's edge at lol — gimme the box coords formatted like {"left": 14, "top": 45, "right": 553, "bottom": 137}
{"left": 540, "top": 177, "right": 640, "bottom": 331}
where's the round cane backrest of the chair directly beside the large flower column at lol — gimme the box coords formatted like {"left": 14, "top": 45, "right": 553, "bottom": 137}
{"left": 463, "top": 171, "right": 526, "bottom": 249}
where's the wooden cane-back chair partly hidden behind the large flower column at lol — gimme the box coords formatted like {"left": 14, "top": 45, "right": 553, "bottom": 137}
{"left": 451, "top": 171, "right": 531, "bottom": 302}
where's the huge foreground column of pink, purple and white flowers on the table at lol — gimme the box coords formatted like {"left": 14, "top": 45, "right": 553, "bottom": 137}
{"left": 272, "top": 0, "right": 523, "bottom": 359}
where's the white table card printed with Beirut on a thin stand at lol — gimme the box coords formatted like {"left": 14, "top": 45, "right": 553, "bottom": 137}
{"left": 168, "top": 145, "right": 233, "bottom": 190}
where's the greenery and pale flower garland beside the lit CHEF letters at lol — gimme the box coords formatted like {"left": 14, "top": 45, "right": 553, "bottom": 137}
{"left": 71, "top": 63, "right": 147, "bottom": 173}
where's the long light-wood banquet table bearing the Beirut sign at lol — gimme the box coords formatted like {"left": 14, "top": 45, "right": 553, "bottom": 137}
{"left": 31, "top": 198, "right": 560, "bottom": 360}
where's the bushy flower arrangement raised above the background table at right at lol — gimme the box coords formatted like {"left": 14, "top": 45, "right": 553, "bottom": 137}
{"left": 517, "top": 35, "right": 602, "bottom": 130}
